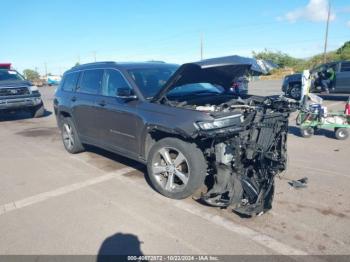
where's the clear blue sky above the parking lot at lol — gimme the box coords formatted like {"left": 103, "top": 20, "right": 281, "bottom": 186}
{"left": 0, "top": 0, "right": 350, "bottom": 74}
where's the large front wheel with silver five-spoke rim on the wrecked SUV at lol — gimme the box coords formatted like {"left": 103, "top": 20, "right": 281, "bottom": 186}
{"left": 147, "top": 138, "right": 207, "bottom": 199}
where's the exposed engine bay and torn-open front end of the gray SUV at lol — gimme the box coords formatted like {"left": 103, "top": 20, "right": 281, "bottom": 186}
{"left": 167, "top": 96, "right": 298, "bottom": 216}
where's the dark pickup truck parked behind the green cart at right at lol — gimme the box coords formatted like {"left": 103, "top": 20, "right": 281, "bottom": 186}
{"left": 282, "top": 61, "right": 350, "bottom": 99}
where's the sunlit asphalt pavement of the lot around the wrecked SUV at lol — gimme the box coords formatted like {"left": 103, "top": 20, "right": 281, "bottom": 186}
{"left": 0, "top": 81, "right": 350, "bottom": 255}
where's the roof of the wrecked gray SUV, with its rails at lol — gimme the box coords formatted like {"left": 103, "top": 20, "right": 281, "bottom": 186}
{"left": 67, "top": 61, "right": 179, "bottom": 72}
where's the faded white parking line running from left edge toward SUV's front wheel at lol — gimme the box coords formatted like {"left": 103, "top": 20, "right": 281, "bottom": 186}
{"left": 0, "top": 167, "right": 135, "bottom": 215}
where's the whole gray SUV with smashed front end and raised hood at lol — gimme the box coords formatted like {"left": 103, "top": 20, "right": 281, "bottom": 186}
{"left": 54, "top": 61, "right": 294, "bottom": 215}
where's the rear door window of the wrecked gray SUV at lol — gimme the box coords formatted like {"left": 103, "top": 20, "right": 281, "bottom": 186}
{"left": 77, "top": 69, "right": 104, "bottom": 95}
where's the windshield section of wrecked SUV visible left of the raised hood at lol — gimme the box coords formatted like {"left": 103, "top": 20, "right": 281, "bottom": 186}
{"left": 129, "top": 65, "right": 178, "bottom": 99}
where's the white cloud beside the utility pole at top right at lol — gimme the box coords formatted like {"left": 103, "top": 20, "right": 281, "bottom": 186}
{"left": 279, "top": 0, "right": 335, "bottom": 22}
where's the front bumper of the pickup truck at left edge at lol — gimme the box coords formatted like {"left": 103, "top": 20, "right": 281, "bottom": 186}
{"left": 0, "top": 95, "right": 42, "bottom": 110}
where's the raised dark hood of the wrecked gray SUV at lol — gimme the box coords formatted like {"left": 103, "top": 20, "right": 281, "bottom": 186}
{"left": 152, "top": 56, "right": 263, "bottom": 101}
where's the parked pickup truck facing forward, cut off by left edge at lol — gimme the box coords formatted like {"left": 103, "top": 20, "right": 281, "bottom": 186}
{"left": 0, "top": 64, "right": 45, "bottom": 117}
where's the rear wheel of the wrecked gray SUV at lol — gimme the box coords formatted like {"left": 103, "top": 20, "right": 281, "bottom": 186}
{"left": 60, "top": 117, "right": 84, "bottom": 154}
